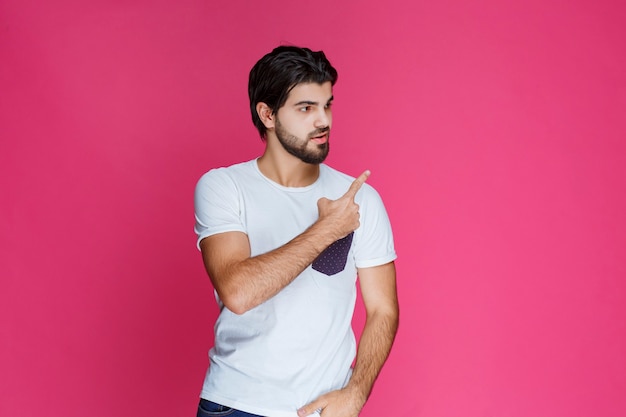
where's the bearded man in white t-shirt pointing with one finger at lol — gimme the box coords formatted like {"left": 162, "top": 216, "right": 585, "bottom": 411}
{"left": 195, "top": 46, "right": 398, "bottom": 417}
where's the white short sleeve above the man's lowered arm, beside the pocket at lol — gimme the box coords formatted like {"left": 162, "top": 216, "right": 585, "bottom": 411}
{"left": 354, "top": 184, "right": 397, "bottom": 268}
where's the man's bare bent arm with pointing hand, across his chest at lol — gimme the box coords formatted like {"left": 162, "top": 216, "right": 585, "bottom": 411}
{"left": 200, "top": 171, "right": 369, "bottom": 314}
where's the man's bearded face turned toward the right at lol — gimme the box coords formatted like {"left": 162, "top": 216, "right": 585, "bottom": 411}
{"left": 275, "top": 82, "right": 333, "bottom": 164}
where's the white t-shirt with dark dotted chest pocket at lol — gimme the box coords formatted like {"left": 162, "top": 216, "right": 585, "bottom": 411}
{"left": 194, "top": 160, "right": 396, "bottom": 417}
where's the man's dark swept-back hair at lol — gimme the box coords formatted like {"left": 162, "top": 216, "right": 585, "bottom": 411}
{"left": 248, "top": 46, "right": 337, "bottom": 139}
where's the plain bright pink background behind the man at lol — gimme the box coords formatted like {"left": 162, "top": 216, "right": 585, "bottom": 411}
{"left": 0, "top": 0, "right": 626, "bottom": 417}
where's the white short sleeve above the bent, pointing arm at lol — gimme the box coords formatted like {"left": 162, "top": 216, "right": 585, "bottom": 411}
{"left": 194, "top": 168, "right": 245, "bottom": 249}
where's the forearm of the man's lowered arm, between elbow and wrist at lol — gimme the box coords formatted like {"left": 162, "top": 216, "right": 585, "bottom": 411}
{"left": 346, "top": 306, "right": 398, "bottom": 406}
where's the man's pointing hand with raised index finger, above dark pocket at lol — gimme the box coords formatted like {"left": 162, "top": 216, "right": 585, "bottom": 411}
{"left": 317, "top": 170, "right": 370, "bottom": 241}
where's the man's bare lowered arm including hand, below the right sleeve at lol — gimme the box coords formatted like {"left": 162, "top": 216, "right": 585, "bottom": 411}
{"left": 298, "top": 262, "right": 399, "bottom": 417}
